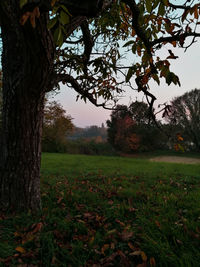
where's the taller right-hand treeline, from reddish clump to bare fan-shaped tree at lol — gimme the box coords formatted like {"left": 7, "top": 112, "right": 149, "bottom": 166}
{"left": 107, "top": 89, "right": 200, "bottom": 153}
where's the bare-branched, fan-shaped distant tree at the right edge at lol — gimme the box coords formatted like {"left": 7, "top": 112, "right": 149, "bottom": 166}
{"left": 166, "top": 89, "right": 200, "bottom": 151}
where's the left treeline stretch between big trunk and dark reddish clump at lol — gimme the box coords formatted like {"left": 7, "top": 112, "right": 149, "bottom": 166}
{"left": 42, "top": 102, "right": 115, "bottom": 155}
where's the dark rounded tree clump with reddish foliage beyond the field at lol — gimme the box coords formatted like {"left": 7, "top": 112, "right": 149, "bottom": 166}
{"left": 107, "top": 101, "right": 166, "bottom": 152}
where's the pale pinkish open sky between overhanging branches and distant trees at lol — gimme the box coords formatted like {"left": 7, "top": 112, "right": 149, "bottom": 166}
{"left": 54, "top": 40, "right": 200, "bottom": 127}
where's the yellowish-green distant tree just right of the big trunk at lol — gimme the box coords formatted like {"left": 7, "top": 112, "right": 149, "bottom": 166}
{"left": 42, "top": 101, "right": 74, "bottom": 152}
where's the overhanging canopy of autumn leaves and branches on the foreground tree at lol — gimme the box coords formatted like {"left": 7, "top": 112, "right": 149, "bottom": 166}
{"left": 8, "top": 0, "right": 200, "bottom": 111}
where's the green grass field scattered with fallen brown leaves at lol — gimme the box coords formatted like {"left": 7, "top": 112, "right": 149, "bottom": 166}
{"left": 0, "top": 154, "right": 200, "bottom": 267}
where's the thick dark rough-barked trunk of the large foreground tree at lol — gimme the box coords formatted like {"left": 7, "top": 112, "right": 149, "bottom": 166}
{"left": 0, "top": 0, "right": 54, "bottom": 211}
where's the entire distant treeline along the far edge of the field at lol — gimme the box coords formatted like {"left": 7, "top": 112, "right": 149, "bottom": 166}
{"left": 0, "top": 87, "right": 200, "bottom": 155}
